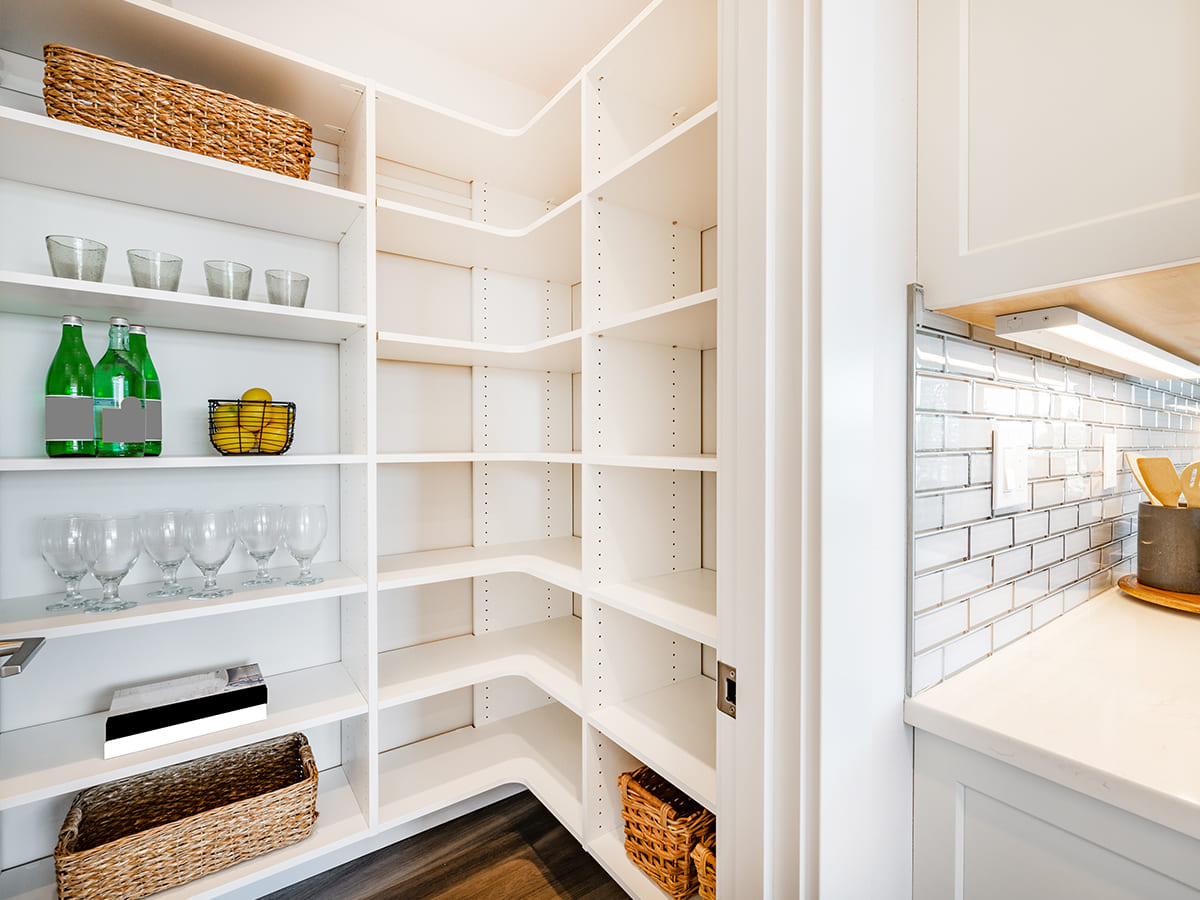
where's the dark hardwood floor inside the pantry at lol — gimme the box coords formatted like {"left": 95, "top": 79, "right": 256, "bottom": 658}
{"left": 263, "top": 791, "right": 625, "bottom": 900}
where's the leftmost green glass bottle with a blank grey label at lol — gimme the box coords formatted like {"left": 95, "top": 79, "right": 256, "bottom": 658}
{"left": 46, "top": 316, "right": 96, "bottom": 456}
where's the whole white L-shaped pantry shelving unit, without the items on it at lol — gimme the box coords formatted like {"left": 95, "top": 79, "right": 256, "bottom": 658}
{"left": 0, "top": 0, "right": 719, "bottom": 900}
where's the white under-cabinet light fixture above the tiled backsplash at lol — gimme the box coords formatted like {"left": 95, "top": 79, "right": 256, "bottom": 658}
{"left": 996, "top": 306, "right": 1200, "bottom": 380}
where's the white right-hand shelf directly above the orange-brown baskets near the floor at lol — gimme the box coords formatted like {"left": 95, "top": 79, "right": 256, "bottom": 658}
{"left": 588, "top": 676, "right": 716, "bottom": 812}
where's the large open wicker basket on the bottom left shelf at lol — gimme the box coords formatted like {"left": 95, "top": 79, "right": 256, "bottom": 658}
{"left": 54, "top": 733, "right": 317, "bottom": 900}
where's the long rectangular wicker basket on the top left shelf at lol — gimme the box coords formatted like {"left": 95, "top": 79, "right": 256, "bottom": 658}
{"left": 43, "top": 43, "right": 312, "bottom": 180}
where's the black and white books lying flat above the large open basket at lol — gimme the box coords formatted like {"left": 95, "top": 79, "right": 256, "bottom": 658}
{"left": 104, "top": 664, "right": 266, "bottom": 760}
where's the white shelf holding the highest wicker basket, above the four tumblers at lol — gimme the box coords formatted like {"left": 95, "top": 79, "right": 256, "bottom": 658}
{"left": 0, "top": 107, "right": 367, "bottom": 244}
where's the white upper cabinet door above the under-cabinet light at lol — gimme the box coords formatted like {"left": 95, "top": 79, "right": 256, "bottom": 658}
{"left": 917, "top": 0, "right": 1200, "bottom": 318}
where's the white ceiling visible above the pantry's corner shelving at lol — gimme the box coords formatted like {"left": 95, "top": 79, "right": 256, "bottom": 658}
{"left": 337, "top": 0, "right": 648, "bottom": 97}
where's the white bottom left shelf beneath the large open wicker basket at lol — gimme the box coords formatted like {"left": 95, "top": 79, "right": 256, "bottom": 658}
{"left": 0, "top": 767, "right": 368, "bottom": 900}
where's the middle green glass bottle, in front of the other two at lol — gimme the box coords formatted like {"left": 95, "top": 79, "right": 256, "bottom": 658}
{"left": 92, "top": 316, "right": 146, "bottom": 456}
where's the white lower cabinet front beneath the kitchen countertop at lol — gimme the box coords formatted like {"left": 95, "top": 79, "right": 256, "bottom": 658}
{"left": 913, "top": 730, "right": 1200, "bottom": 900}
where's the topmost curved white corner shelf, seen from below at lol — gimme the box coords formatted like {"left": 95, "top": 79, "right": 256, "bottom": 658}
{"left": 376, "top": 76, "right": 581, "bottom": 204}
